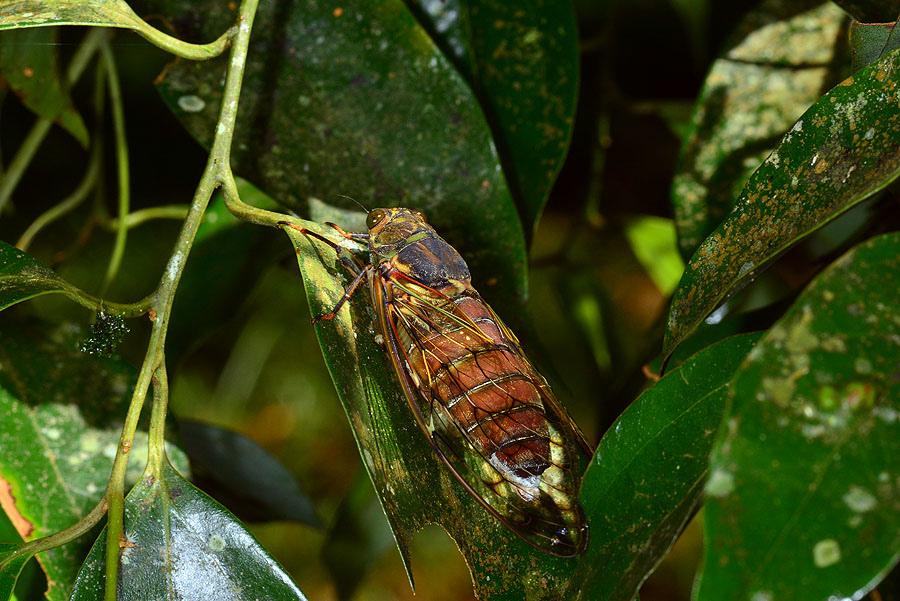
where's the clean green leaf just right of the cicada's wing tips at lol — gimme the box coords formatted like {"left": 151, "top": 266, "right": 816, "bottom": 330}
{"left": 572, "top": 334, "right": 761, "bottom": 601}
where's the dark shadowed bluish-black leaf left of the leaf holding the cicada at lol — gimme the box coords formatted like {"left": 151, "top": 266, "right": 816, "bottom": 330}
{"left": 178, "top": 421, "right": 322, "bottom": 528}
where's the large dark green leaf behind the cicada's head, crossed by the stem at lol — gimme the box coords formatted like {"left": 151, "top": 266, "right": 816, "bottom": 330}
{"left": 146, "top": 0, "right": 525, "bottom": 306}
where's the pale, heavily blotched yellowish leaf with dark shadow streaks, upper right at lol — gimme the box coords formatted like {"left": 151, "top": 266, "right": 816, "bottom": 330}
{"left": 672, "top": 0, "right": 846, "bottom": 259}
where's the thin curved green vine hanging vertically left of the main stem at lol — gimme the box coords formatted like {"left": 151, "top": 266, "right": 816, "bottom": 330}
{"left": 99, "top": 40, "right": 131, "bottom": 297}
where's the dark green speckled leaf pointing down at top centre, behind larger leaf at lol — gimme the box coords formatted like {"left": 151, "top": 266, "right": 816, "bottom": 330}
{"left": 408, "top": 0, "right": 578, "bottom": 236}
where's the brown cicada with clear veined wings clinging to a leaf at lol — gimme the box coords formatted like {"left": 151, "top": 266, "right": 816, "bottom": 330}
{"left": 284, "top": 208, "right": 591, "bottom": 557}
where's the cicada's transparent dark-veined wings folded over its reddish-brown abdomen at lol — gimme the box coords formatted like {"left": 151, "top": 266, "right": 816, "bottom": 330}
{"left": 374, "top": 278, "right": 587, "bottom": 556}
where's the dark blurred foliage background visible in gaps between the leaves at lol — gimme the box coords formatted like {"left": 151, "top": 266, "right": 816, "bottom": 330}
{"left": 0, "top": 0, "right": 880, "bottom": 601}
